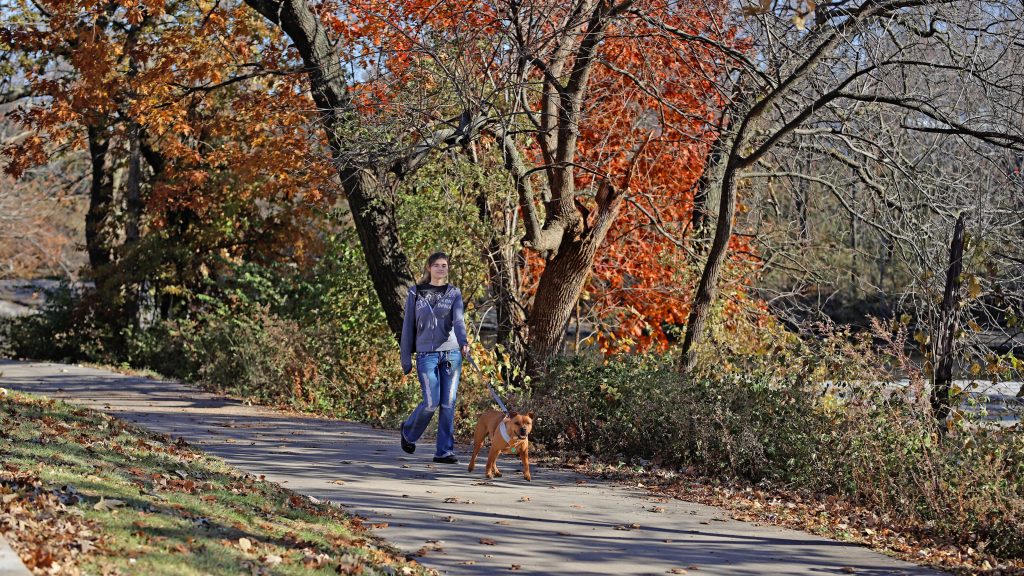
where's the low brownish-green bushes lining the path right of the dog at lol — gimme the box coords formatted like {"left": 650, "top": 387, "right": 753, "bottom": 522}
{"left": 532, "top": 323, "right": 1024, "bottom": 557}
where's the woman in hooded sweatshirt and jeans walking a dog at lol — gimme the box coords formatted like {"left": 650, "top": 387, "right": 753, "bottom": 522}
{"left": 401, "top": 252, "right": 469, "bottom": 464}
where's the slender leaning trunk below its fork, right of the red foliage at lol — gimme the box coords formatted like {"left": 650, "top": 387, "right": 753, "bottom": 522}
{"left": 679, "top": 158, "right": 736, "bottom": 376}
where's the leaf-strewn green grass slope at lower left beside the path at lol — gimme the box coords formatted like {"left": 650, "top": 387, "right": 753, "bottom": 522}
{"left": 0, "top": 387, "right": 426, "bottom": 576}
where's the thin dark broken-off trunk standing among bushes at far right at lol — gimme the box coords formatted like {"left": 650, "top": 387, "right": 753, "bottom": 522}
{"left": 931, "top": 213, "right": 965, "bottom": 423}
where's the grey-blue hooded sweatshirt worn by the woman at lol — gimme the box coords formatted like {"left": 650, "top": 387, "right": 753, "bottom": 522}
{"left": 400, "top": 285, "right": 469, "bottom": 374}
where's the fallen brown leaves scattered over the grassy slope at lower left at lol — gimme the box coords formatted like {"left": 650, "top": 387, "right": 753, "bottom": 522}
{"left": 0, "top": 396, "right": 432, "bottom": 576}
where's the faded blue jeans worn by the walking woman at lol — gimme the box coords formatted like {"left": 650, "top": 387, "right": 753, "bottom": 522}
{"left": 401, "top": 349, "right": 462, "bottom": 456}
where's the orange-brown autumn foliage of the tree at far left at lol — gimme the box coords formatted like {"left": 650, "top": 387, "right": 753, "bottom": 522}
{"left": 0, "top": 0, "right": 335, "bottom": 278}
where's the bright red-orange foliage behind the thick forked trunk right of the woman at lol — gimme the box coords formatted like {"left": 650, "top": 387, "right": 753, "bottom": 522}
{"left": 520, "top": 1, "right": 752, "bottom": 353}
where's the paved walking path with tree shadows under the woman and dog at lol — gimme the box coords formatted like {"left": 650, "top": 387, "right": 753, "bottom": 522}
{"left": 0, "top": 360, "right": 941, "bottom": 575}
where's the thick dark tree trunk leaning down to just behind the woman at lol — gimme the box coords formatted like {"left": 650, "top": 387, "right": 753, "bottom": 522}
{"left": 246, "top": 0, "right": 415, "bottom": 338}
